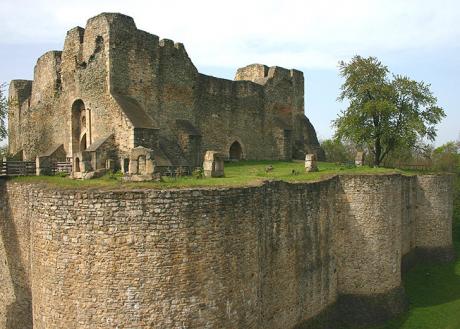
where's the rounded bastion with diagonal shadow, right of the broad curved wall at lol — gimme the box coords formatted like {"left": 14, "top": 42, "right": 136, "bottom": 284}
{"left": 335, "top": 175, "right": 402, "bottom": 294}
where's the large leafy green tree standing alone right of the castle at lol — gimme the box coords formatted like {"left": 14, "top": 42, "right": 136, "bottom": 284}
{"left": 333, "top": 56, "right": 445, "bottom": 166}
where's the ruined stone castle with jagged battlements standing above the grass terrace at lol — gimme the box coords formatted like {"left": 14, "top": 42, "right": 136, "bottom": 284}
{"left": 8, "top": 13, "right": 323, "bottom": 173}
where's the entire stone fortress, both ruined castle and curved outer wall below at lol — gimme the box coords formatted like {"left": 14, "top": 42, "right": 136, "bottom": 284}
{"left": 0, "top": 14, "right": 454, "bottom": 329}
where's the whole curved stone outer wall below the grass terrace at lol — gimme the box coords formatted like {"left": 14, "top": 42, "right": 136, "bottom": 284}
{"left": 0, "top": 175, "right": 452, "bottom": 329}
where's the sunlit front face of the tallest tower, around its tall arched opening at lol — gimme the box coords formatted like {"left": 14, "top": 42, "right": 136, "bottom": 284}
{"left": 59, "top": 14, "right": 134, "bottom": 152}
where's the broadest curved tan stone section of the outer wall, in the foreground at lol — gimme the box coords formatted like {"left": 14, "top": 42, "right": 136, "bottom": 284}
{"left": 0, "top": 180, "right": 336, "bottom": 329}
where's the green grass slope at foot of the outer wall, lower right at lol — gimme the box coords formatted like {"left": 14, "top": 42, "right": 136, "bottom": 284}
{"left": 372, "top": 174, "right": 460, "bottom": 329}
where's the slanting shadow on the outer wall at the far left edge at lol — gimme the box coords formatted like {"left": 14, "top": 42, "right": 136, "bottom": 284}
{"left": 0, "top": 179, "right": 33, "bottom": 329}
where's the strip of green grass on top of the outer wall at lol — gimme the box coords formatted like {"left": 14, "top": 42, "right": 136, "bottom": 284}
{"left": 7, "top": 161, "right": 408, "bottom": 189}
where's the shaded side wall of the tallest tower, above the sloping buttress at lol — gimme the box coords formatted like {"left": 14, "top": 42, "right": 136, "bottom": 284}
{"left": 99, "top": 14, "right": 198, "bottom": 138}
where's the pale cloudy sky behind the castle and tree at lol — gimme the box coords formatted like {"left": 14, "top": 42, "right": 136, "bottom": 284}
{"left": 0, "top": 0, "right": 460, "bottom": 145}
